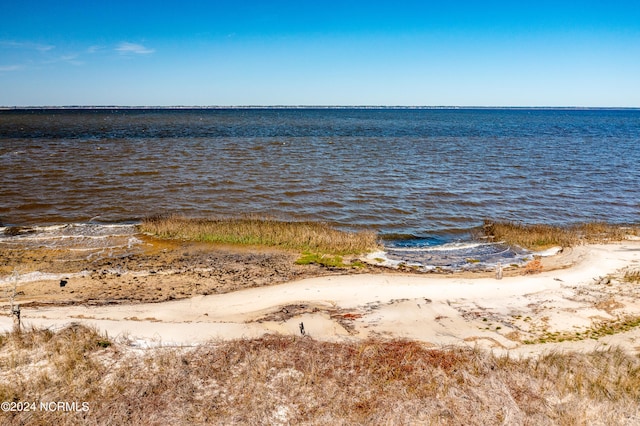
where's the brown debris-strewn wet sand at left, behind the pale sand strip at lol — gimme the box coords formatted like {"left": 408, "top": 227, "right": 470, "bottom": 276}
{"left": 0, "top": 235, "right": 356, "bottom": 307}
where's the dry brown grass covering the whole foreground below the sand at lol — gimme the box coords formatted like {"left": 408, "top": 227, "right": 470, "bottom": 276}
{"left": 0, "top": 327, "right": 640, "bottom": 425}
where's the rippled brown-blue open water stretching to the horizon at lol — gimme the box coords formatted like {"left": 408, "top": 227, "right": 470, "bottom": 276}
{"left": 0, "top": 109, "right": 640, "bottom": 270}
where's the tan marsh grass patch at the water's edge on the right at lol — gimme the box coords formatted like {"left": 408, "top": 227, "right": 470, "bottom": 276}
{"left": 476, "top": 221, "right": 640, "bottom": 250}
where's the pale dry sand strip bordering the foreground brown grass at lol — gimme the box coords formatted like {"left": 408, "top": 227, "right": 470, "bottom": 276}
{"left": 0, "top": 241, "right": 640, "bottom": 355}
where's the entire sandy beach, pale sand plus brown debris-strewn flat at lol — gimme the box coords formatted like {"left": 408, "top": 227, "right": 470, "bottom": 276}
{"left": 0, "top": 240, "right": 640, "bottom": 355}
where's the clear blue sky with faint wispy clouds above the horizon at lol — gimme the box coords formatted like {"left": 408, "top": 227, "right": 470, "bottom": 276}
{"left": 0, "top": 0, "right": 640, "bottom": 107}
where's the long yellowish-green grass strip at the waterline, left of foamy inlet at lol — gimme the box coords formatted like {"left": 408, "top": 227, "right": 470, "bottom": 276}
{"left": 139, "top": 215, "right": 379, "bottom": 254}
